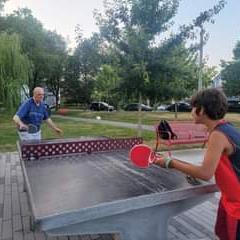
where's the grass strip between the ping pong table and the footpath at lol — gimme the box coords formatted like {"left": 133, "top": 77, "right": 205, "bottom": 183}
{"left": 0, "top": 110, "right": 155, "bottom": 152}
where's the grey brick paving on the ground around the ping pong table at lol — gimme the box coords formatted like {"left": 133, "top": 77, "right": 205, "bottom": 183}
{"left": 0, "top": 152, "right": 219, "bottom": 240}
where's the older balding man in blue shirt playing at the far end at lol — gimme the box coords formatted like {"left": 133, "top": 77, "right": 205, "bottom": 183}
{"left": 13, "top": 87, "right": 62, "bottom": 140}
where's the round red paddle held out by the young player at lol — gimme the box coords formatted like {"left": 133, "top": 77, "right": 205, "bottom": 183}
{"left": 129, "top": 144, "right": 160, "bottom": 168}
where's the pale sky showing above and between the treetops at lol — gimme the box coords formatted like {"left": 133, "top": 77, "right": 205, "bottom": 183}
{"left": 4, "top": 0, "right": 240, "bottom": 66}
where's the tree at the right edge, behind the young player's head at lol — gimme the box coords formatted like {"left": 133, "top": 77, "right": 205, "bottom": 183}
{"left": 221, "top": 41, "right": 240, "bottom": 96}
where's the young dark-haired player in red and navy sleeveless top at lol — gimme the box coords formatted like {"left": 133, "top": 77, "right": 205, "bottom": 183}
{"left": 154, "top": 89, "right": 240, "bottom": 240}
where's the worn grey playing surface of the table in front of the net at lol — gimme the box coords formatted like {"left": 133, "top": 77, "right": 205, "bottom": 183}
{"left": 20, "top": 140, "right": 214, "bottom": 224}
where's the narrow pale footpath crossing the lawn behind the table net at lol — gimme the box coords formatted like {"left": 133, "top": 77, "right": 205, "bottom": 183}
{"left": 53, "top": 115, "right": 155, "bottom": 131}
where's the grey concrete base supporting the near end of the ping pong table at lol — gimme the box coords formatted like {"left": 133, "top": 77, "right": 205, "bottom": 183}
{"left": 43, "top": 194, "right": 212, "bottom": 240}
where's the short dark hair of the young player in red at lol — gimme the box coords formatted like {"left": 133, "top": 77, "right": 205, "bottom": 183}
{"left": 191, "top": 88, "right": 228, "bottom": 120}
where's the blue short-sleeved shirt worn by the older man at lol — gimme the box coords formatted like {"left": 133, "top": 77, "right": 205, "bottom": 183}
{"left": 16, "top": 98, "right": 49, "bottom": 129}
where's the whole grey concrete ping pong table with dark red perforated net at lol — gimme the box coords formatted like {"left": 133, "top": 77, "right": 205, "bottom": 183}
{"left": 18, "top": 137, "right": 217, "bottom": 240}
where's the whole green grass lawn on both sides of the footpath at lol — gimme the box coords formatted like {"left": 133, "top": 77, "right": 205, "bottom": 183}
{"left": 0, "top": 110, "right": 240, "bottom": 152}
